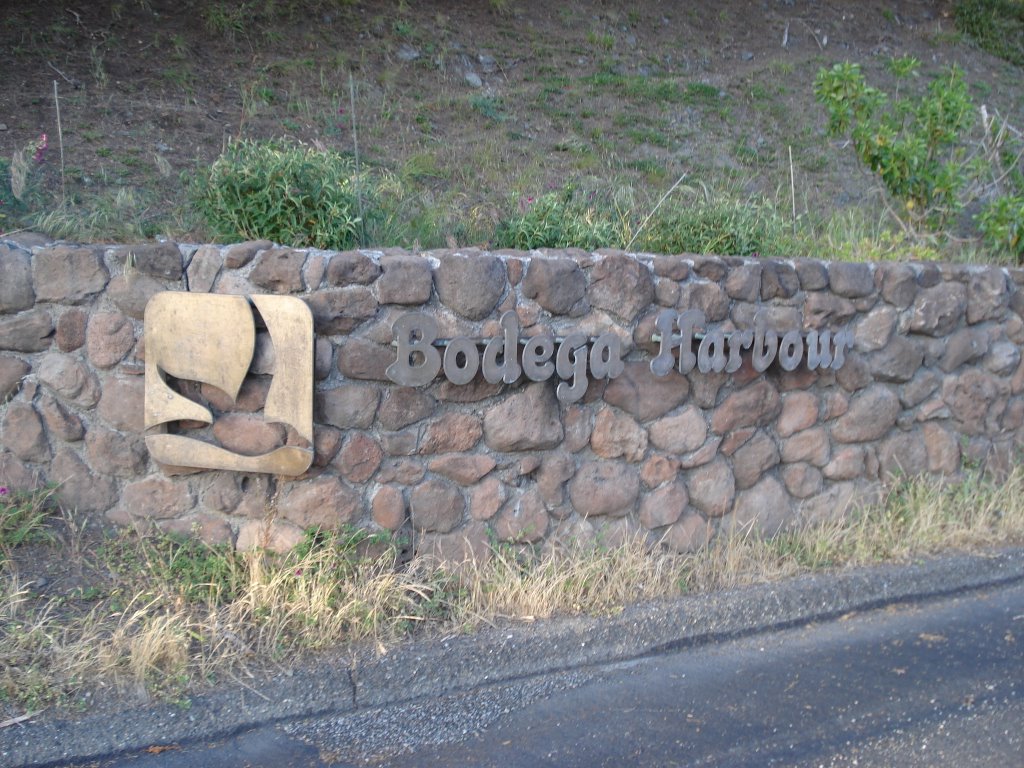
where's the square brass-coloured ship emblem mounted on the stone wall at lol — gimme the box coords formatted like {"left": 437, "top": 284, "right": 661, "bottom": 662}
{"left": 145, "top": 292, "right": 313, "bottom": 475}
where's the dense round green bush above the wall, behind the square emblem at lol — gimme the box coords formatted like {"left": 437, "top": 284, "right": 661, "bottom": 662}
{"left": 190, "top": 140, "right": 373, "bottom": 249}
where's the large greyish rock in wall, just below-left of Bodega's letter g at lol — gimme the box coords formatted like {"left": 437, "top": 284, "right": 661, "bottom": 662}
{"left": 483, "top": 382, "right": 564, "bottom": 451}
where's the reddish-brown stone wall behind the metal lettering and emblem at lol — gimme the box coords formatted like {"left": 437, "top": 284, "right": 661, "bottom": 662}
{"left": 0, "top": 236, "right": 1024, "bottom": 557}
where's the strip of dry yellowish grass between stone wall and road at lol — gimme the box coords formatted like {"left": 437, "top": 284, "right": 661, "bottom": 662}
{"left": 0, "top": 469, "right": 1024, "bottom": 712}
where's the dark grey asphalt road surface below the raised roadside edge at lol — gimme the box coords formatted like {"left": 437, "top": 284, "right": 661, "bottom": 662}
{"left": 88, "top": 583, "right": 1024, "bottom": 768}
